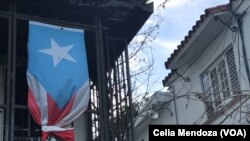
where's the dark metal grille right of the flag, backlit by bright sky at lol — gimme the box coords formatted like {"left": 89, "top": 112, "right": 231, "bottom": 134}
{"left": 88, "top": 38, "right": 132, "bottom": 141}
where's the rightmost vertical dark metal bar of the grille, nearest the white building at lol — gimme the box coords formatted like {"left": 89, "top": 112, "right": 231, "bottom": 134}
{"left": 125, "top": 40, "right": 134, "bottom": 141}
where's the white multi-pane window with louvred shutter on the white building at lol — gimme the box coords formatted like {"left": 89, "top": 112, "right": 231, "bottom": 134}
{"left": 201, "top": 47, "right": 240, "bottom": 118}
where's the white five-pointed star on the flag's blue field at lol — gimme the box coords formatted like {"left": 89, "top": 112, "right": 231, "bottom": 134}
{"left": 39, "top": 38, "right": 76, "bottom": 67}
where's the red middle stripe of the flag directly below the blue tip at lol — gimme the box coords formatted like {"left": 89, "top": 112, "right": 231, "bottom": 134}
{"left": 47, "top": 94, "right": 75, "bottom": 125}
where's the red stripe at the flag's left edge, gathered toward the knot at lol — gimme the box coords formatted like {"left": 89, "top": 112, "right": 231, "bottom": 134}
{"left": 28, "top": 88, "right": 41, "bottom": 125}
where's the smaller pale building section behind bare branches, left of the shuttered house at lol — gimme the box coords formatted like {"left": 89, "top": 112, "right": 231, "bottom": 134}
{"left": 134, "top": 92, "right": 174, "bottom": 141}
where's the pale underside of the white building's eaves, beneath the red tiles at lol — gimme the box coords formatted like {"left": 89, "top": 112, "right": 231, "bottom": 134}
{"left": 166, "top": 11, "right": 231, "bottom": 70}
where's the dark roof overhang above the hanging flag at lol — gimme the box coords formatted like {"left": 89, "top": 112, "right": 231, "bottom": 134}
{"left": 13, "top": 0, "right": 153, "bottom": 42}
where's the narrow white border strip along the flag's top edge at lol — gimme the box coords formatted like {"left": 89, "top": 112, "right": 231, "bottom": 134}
{"left": 29, "top": 21, "right": 84, "bottom": 33}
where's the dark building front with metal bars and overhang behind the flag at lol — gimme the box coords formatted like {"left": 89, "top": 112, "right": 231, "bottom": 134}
{"left": 0, "top": 0, "right": 153, "bottom": 141}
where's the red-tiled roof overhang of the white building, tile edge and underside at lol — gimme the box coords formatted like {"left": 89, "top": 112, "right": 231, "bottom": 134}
{"left": 163, "top": 2, "right": 232, "bottom": 86}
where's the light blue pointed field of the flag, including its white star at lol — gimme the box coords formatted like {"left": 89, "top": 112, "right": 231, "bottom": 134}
{"left": 28, "top": 22, "right": 89, "bottom": 108}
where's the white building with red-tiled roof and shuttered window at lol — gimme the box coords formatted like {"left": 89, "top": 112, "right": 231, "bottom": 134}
{"left": 136, "top": 0, "right": 250, "bottom": 141}
